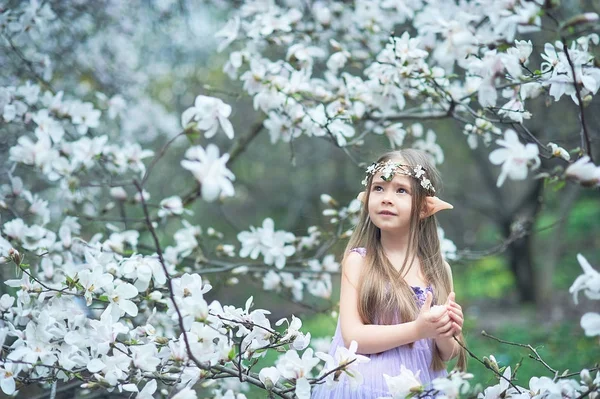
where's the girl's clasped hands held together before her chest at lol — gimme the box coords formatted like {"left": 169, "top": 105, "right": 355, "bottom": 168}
{"left": 415, "top": 291, "right": 463, "bottom": 338}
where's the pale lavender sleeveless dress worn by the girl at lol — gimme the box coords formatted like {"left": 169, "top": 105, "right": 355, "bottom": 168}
{"left": 312, "top": 248, "right": 448, "bottom": 399}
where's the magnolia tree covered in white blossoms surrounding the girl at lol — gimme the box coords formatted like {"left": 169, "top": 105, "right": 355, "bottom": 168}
{"left": 0, "top": 0, "right": 600, "bottom": 399}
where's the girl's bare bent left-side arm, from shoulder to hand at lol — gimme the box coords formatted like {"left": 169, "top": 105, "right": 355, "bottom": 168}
{"left": 340, "top": 252, "right": 449, "bottom": 354}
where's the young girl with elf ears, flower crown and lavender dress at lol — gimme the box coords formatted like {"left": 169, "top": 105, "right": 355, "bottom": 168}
{"left": 312, "top": 149, "right": 466, "bottom": 399}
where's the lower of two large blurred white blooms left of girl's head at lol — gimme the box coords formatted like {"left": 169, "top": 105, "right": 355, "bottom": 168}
{"left": 181, "top": 144, "right": 235, "bottom": 202}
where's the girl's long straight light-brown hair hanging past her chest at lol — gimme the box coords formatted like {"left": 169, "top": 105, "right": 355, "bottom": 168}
{"left": 345, "top": 149, "right": 466, "bottom": 370}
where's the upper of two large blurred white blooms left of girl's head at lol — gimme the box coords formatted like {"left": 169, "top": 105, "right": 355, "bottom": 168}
{"left": 181, "top": 95, "right": 233, "bottom": 139}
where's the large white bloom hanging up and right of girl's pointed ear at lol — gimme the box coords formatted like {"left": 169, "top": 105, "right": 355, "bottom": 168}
{"left": 490, "top": 129, "right": 540, "bottom": 187}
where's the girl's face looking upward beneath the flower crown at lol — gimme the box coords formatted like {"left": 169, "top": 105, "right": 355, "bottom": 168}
{"left": 368, "top": 173, "right": 412, "bottom": 232}
